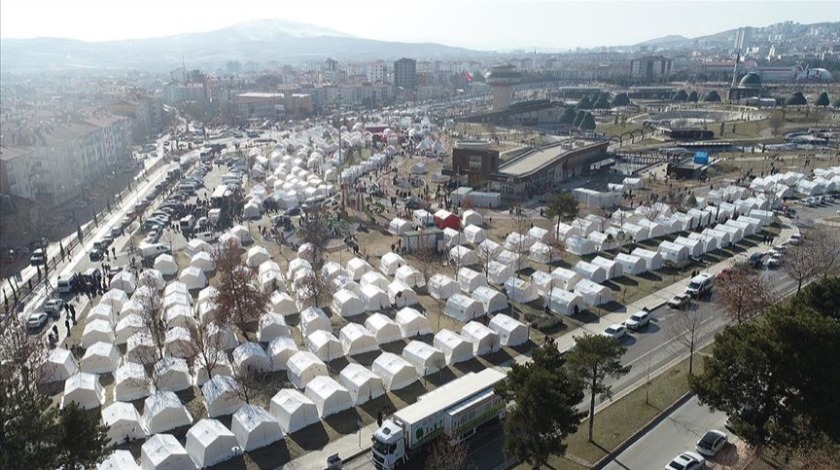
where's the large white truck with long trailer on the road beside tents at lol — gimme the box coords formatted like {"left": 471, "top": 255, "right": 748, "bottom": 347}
{"left": 371, "top": 369, "right": 506, "bottom": 470}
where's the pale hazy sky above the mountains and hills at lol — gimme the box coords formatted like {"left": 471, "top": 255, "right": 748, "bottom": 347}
{"left": 0, "top": 0, "right": 840, "bottom": 50}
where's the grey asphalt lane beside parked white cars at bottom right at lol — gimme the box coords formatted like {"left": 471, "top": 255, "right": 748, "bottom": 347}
{"left": 605, "top": 397, "right": 733, "bottom": 470}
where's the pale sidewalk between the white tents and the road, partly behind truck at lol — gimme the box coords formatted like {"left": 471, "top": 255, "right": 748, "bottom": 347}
{"left": 278, "top": 217, "right": 799, "bottom": 470}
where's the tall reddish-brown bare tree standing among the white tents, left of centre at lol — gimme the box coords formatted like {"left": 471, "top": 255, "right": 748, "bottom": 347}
{"left": 213, "top": 241, "right": 271, "bottom": 335}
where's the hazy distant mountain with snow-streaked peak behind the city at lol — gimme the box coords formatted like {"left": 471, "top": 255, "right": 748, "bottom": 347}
{"left": 0, "top": 19, "right": 474, "bottom": 71}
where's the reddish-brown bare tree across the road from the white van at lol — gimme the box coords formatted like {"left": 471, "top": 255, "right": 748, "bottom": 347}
{"left": 717, "top": 263, "right": 776, "bottom": 323}
